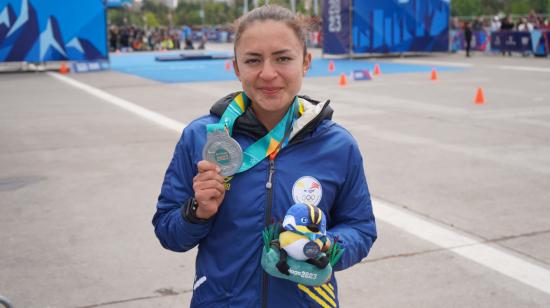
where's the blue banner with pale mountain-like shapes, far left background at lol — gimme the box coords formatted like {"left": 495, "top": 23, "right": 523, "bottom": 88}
{"left": 0, "top": 0, "right": 108, "bottom": 62}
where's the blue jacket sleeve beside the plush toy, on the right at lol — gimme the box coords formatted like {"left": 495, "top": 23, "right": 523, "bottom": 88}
{"left": 327, "top": 143, "right": 377, "bottom": 271}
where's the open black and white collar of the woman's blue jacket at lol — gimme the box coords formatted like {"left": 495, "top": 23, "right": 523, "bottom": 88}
{"left": 210, "top": 92, "right": 334, "bottom": 143}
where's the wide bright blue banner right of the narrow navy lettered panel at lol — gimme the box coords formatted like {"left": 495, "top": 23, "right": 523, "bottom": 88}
{"left": 352, "top": 0, "right": 450, "bottom": 53}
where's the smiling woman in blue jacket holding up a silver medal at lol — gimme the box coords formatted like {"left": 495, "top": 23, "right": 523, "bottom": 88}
{"left": 153, "top": 6, "right": 376, "bottom": 307}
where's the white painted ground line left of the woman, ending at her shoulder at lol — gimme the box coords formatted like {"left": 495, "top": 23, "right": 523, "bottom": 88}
{"left": 47, "top": 72, "right": 186, "bottom": 133}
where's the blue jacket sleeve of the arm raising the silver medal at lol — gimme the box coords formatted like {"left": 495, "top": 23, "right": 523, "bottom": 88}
{"left": 153, "top": 132, "right": 212, "bottom": 252}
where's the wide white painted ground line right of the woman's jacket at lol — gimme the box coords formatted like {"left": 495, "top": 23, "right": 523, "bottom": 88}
{"left": 378, "top": 198, "right": 550, "bottom": 294}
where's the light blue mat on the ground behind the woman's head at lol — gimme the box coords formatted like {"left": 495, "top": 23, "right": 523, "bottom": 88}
{"left": 110, "top": 51, "right": 463, "bottom": 83}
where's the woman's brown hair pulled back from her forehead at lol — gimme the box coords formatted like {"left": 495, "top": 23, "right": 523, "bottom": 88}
{"left": 233, "top": 5, "right": 310, "bottom": 57}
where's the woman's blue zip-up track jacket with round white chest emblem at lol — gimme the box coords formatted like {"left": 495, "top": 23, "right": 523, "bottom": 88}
{"left": 153, "top": 93, "right": 376, "bottom": 308}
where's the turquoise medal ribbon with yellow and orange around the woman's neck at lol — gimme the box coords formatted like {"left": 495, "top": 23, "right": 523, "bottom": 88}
{"left": 206, "top": 92, "right": 303, "bottom": 173}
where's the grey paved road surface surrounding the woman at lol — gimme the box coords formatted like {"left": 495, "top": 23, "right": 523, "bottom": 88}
{"left": 0, "top": 46, "right": 550, "bottom": 308}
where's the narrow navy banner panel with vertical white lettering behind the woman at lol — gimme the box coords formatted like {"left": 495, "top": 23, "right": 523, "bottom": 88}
{"left": 323, "top": 0, "right": 351, "bottom": 54}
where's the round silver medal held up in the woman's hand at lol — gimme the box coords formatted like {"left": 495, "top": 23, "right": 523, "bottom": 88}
{"left": 202, "top": 131, "right": 243, "bottom": 176}
